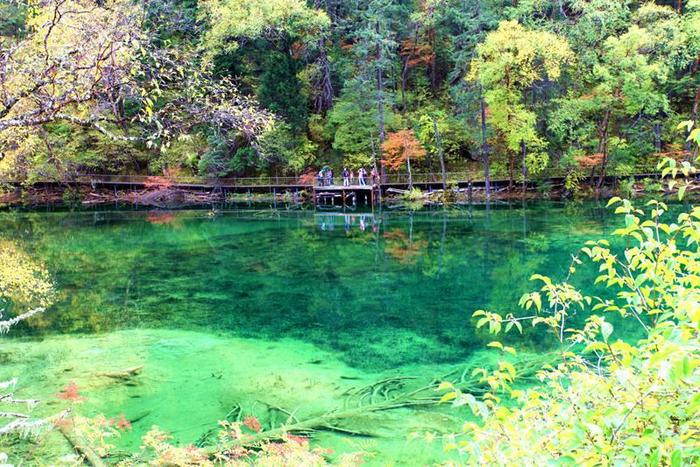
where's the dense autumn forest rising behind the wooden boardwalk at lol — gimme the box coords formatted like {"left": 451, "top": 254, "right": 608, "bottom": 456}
{"left": 0, "top": 0, "right": 700, "bottom": 193}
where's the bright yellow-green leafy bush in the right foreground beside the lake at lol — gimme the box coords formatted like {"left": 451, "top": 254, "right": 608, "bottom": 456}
{"left": 443, "top": 188, "right": 700, "bottom": 466}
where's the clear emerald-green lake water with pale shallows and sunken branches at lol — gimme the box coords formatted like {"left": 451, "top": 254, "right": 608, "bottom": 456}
{"left": 0, "top": 203, "right": 632, "bottom": 465}
